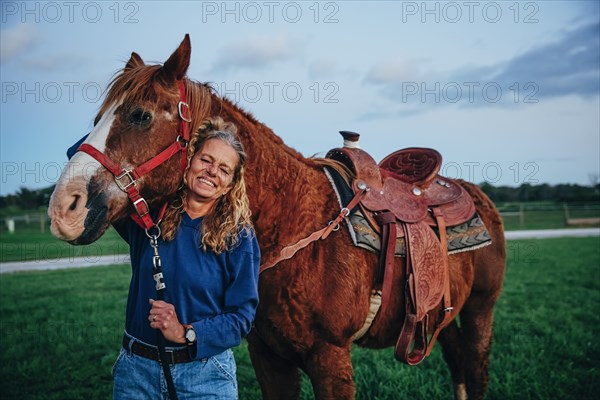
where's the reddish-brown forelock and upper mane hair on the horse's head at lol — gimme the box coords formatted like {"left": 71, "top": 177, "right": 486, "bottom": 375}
{"left": 94, "top": 64, "right": 214, "bottom": 131}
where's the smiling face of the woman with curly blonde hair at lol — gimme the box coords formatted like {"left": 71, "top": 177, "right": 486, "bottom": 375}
{"left": 186, "top": 139, "right": 239, "bottom": 205}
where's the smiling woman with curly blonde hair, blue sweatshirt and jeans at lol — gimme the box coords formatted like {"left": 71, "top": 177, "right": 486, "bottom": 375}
{"left": 113, "top": 118, "right": 260, "bottom": 399}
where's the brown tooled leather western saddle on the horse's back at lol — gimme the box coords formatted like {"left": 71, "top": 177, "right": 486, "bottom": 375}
{"left": 326, "top": 131, "right": 475, "bottom": 365}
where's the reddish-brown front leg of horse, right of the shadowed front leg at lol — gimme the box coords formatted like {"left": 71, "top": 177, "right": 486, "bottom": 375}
{"left": 305, "top": 343, "right": 354, "bottom": 400}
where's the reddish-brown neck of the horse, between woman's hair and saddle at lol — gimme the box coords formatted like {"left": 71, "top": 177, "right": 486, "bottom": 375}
{"left": 211, "top": 99, "right": 335, "bottom": 246}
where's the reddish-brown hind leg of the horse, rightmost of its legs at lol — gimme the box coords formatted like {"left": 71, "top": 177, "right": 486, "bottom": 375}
{"left": 460, "top": 292, "right": 495, "bottom": 400}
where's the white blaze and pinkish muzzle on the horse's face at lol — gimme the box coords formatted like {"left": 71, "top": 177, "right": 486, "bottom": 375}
{"left": 48, "top": 101, "right": 121, "bottom": 240}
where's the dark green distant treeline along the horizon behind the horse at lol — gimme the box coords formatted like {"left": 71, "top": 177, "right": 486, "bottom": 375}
{"left": 0, "top": 182, "right": 600, "bottom": 213}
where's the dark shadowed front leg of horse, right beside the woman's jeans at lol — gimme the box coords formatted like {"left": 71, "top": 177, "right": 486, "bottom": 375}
{"left": 247, "top": 330, "right": 300, "bottom": 400}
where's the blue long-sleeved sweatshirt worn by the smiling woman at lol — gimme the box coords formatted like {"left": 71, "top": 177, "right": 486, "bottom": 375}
{"left": 115, "top": 212, "right": 260, "bottom": 359}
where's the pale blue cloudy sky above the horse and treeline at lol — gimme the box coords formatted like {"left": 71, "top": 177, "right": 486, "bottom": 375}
{"left": 0, "top": 1, "right": 600, "bottom": 195}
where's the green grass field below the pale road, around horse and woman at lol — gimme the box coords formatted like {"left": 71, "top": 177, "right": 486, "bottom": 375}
{"left": 0, "top": 238, "right": 600, "bottom": 400}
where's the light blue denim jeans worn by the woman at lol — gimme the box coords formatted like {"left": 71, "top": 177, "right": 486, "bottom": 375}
{"left": 113, "top": 336, "right": 238, "bottom": 400}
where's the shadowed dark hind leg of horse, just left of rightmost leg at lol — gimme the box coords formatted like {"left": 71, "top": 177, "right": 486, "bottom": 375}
{"left": 438, "top": 320, "right": 467, "bottom": 400}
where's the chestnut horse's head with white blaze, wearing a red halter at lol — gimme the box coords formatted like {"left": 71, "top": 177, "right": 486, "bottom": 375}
{"left": 48, "top": 35, "right": 210, "bottom": 244}
